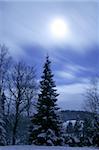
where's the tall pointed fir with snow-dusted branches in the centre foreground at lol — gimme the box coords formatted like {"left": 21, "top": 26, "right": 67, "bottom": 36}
{"left": 29, "top": 56, "right": 63, "bottom": 145}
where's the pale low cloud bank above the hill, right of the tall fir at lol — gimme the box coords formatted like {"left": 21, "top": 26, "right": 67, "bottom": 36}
{"left": 57, "top": 83, "right": 88, "bottom": 109}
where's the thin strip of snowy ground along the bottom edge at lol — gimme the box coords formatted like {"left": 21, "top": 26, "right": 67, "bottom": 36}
{"left": 0, "top": 146, "right": 99, "bottom": 150}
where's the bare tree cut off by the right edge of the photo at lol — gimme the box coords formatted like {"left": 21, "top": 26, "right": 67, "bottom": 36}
{"left": 85, "top": 78, "right": 99, "bottom": 146}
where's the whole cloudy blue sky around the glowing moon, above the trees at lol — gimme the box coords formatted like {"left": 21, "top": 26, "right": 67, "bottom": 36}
{"left": 0, "top": 0, "right": 99, "bottom": 109}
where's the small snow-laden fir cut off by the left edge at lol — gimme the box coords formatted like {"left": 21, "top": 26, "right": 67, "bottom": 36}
{"left": 0, "top": 90, "right": 6, "bottom": 145}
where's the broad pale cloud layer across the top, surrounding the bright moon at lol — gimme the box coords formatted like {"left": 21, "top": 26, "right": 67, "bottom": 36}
{"left": 0, "top": 1, "right": 99, "bottom": 49}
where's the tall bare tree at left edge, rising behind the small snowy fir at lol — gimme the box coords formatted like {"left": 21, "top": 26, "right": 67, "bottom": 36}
{"left": 0, "top": 45, "right": 11, "bottom": 113}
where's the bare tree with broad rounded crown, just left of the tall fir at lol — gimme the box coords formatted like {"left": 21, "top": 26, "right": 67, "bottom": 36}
{"left": 9, "top": 62, "right": 36, "bottom": 145}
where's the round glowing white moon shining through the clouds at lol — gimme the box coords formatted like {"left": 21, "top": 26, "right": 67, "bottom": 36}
{"left": 50, "top": 18, "right": 69, "bottom": 39}
